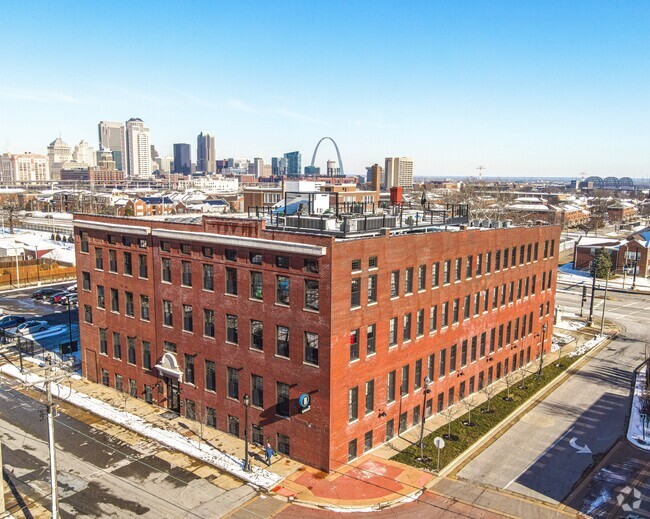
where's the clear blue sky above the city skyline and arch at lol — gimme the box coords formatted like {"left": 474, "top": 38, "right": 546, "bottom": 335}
{"left": 0, "top": 0, "right": 650, "bottom": 177}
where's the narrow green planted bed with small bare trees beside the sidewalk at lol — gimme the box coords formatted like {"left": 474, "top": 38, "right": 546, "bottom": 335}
{"left": 392, "top": 356, "right": 592, "bottom": 470}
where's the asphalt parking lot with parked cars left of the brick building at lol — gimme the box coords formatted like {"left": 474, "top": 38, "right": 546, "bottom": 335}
{"left": 0, "top": 281, "right": 79, "bottom": 325}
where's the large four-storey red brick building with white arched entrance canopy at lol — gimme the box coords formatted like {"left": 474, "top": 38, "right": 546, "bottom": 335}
{"left": 74, "top": 215, "right": 560, "bottom": 476}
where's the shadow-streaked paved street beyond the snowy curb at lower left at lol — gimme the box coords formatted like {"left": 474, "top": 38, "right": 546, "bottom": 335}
{"left": 0, "top": 379, "right": 255, "bottom": 518}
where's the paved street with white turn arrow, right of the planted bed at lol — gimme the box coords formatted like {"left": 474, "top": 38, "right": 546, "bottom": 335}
{"left": 450, "top": 287, "right": 650, "bottom": 504}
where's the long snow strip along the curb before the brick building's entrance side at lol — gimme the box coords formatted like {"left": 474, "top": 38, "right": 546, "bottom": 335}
{"left": 0, "top": 364, "right": 282, "bottom": 489}
